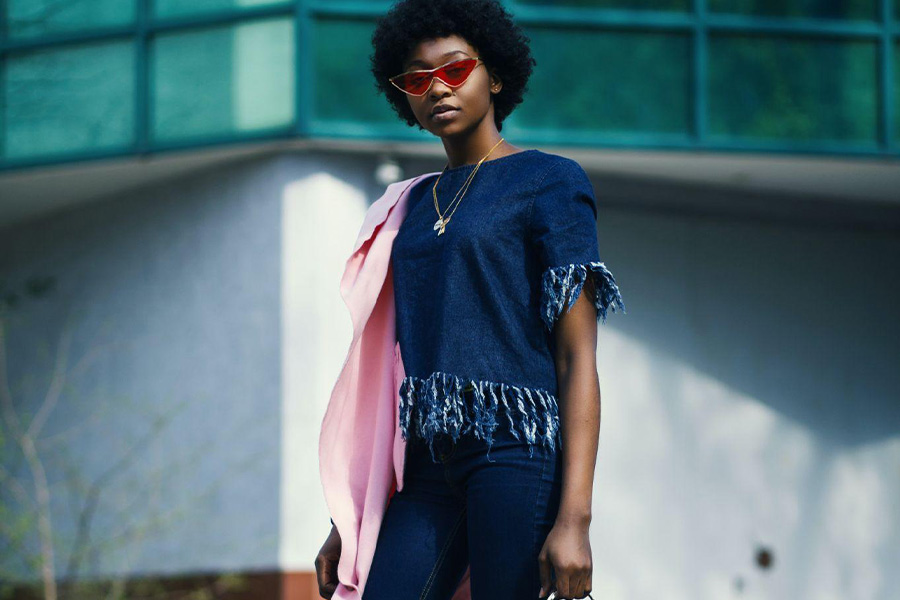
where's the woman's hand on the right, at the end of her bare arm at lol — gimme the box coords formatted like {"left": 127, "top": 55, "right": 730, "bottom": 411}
{"left": 538, "top": 519, "right": 593, "bottom": 600}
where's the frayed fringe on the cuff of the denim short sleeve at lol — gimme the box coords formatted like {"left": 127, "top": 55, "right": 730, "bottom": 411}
{"left": 541, "top": 261, "right": 625, "bottom": 331}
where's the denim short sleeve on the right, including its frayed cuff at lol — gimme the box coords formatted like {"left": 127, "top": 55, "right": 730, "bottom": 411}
{"left": 529, "top": 159, "right": 625, "bottom": 331}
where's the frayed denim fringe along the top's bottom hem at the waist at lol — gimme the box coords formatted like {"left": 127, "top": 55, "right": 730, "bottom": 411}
{"left": 400, "top": 371, "right": 561, "bottom": 462}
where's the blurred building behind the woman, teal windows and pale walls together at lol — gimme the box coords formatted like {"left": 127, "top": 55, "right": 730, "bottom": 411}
{"left": 0, "top": 0, "right": 900, "bottom": 600}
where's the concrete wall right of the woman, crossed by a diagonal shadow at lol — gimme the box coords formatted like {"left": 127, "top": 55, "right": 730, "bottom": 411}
{"left": 592, "top": 207, "right": 900, "bottom": 600}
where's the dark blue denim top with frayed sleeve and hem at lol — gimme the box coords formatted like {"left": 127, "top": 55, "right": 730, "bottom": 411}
{"left": 390, "top": 149, "right": 625, "bottom": 461}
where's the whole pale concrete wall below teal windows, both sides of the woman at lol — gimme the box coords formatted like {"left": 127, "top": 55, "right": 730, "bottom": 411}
{"left": 0, "top": 155, "right": 900, "bottom": 600}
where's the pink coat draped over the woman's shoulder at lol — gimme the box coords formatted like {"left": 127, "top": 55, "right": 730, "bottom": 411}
{"left": 319, "top": 172, "right": 471, "bottom": 600}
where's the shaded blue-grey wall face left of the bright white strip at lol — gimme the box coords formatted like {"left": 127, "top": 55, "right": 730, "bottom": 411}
{"left": 0, "top": 155, "right": 282, "bottom": 576}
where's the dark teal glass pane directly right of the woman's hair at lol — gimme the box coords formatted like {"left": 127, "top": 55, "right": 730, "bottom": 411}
{"left": 510, "top": 28, "right": 691, "bottom": 133}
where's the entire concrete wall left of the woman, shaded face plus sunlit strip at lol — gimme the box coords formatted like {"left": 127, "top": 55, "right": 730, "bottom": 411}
{"left": 0, "top": 155, "right": 380, "bottom": 575}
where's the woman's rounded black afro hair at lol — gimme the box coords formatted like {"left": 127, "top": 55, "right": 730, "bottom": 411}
{"left": 370, "top": 0, "right": 537, "bottom": 131}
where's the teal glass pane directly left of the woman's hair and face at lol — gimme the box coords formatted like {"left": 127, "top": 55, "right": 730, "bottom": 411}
{"left": 312, "top": 19, "right": 406, "bottom": 126}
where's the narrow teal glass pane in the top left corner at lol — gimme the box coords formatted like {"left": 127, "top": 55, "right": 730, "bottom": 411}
{"left": 6, "top": 0, "right": 136, "bottom": 39}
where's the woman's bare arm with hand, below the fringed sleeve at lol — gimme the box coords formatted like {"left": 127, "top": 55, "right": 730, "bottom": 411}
{"left": 539, "top": 278, "right": 600, "bottom": 598}
